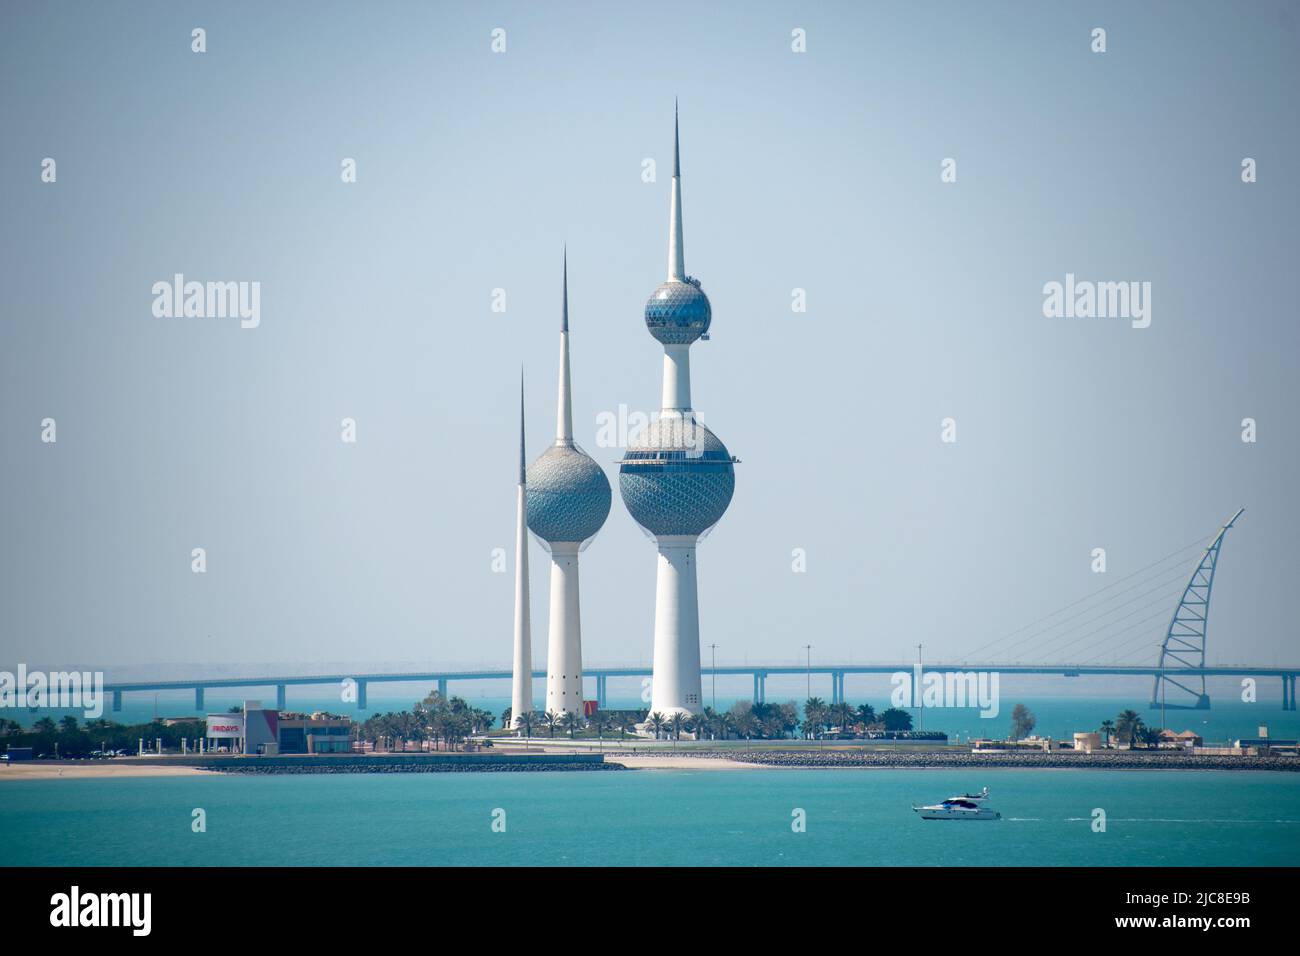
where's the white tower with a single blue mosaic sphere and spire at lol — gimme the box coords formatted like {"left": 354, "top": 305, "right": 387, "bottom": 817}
{"left": 516, "top": 255, "right": 611, "bottom": 715}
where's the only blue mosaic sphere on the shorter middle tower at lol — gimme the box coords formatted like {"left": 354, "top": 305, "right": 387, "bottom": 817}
{"left": 528, "top": 445, "right": 614, "bottom": 542}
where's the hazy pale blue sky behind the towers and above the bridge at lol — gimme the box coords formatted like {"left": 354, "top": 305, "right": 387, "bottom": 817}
{"left": 0, "top": 3, "right": 1300, "bottom": 666}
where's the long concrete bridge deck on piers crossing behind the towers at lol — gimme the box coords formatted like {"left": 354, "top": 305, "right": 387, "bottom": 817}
{"left": 104, "top": 661, "right": 1300, "bottom": 711}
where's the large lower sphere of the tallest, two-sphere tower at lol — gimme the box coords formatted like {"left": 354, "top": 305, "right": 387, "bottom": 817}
{"left": 619, "top": 416, "right": 736, "bottom": 537}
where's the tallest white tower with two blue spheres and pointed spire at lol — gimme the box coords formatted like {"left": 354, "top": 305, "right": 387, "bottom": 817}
{"left": 621, "top": 111, "right": 736, "bottom": 717}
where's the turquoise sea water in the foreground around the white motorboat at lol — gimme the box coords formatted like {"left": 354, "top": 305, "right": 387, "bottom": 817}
{"left": 0, "top": 770, "right": 1300, "bottom": 866}
